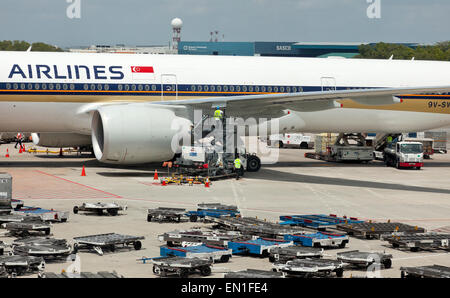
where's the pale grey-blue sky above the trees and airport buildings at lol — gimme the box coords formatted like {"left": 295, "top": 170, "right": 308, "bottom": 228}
{"left": 0, "top": 0, "right": 450, "bottom": 47}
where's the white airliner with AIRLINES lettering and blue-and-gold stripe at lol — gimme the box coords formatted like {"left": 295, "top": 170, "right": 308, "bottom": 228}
{"left": 0, "top": 52, "right": 450, "bottom": 164}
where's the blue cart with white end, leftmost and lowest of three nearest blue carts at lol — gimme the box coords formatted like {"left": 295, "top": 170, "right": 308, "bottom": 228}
{"left": 160, "top": 244, "right": 232, "bottom": 263}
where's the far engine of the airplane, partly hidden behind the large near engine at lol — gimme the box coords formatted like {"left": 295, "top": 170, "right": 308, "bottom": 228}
{"left": 31, "top": 133, "right": 91, "bottom": 148}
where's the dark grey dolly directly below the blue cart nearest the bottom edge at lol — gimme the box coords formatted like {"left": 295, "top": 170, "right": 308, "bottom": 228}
{"left": 151, "top": 257, "right": 212, "bottom": 278}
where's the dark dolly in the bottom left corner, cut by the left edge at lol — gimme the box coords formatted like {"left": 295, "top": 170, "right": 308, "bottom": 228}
{"left": 0, "top": 256, "right": 45, "bottom": 277}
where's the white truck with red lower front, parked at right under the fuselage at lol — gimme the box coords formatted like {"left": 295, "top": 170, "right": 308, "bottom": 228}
{"left": 384, "top": 141, "right": 423, "bottom": 170}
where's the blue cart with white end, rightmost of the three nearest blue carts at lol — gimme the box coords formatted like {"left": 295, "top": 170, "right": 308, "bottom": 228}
{"left": 284, "top": 232, "right": 349, "bottom": 248}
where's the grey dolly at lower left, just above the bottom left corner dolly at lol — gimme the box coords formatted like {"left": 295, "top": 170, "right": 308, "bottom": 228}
{"left": 12, "top": 237, "right": 72, "bottom": 260}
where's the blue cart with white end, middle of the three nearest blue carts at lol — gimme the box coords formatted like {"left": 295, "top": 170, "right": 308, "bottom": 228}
{"left": 228, "top": 238, "right": 294, "bottom": 258}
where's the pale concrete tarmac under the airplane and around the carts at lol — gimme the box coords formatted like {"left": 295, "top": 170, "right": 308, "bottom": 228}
{"left": 0, "top": 143, "right": 450, "bottom": 278}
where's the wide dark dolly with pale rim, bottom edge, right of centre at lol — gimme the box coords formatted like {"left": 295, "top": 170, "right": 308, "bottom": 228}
{"left": 274, "top": 259, "right": 347, "bottom": 278}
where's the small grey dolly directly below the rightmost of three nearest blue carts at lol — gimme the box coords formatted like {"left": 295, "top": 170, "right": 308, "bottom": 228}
{"left": 269, "top": 245, "right": 323, "bottom": 263}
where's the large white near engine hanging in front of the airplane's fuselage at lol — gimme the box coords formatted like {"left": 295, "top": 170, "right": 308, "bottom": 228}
{"left": 92, "top": 104, "right": 192, "bottom": 164}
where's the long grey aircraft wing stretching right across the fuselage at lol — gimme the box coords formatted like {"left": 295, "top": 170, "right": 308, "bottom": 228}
{"left": 152, "top": 86, "right": 450, "bottom": 118}
